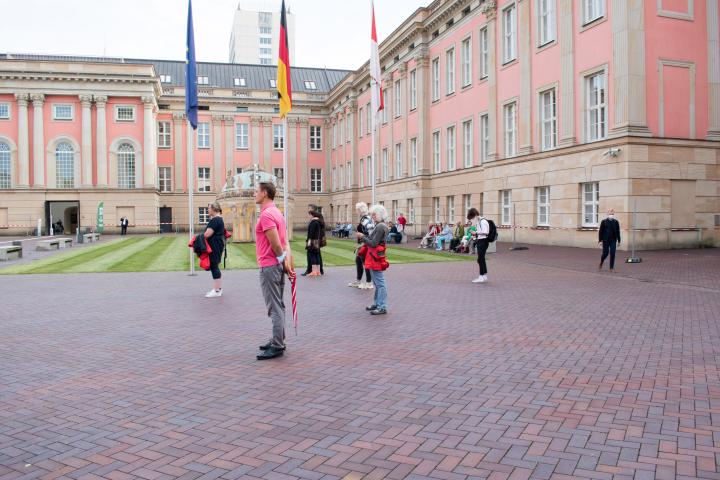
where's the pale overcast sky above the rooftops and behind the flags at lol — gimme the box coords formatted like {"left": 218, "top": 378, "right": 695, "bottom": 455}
{"left": 0, "top": 0, "right": 430, "bottom": 70}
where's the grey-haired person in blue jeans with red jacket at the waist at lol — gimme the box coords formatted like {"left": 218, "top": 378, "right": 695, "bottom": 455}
{"left": 356, "top": 205, "right": 388, "bottom": 315}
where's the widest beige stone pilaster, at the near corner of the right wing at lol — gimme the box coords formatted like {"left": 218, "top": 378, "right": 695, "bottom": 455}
{"left": 610, "top": 0, "right": 650, "bottom": 137}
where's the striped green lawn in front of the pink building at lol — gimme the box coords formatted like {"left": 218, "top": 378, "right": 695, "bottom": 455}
{"left": 0, "top": 235, "right": 473, "bottom": 275}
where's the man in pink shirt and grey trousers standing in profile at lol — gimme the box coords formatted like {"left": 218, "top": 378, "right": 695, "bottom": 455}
{"left": 255, "top": 182, "right": 290, "bottom": 360}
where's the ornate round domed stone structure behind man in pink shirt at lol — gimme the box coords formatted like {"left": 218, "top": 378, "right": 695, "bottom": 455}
{"left": 217, "top": 164, "right": 293, "bottom": 242}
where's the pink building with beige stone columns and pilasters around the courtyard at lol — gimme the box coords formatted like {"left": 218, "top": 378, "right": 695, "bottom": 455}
{"left": 0, "top": 0, "right": 720, "bottom": 248}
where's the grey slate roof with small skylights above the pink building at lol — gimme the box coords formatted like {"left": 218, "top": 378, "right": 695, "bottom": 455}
{"left": 0, "top": 53, "right": 350, "bottom": 93}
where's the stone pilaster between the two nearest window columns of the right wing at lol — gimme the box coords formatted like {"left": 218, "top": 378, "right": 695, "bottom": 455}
{"left": 556, "top": 0, "right": 577, "bottom": 147}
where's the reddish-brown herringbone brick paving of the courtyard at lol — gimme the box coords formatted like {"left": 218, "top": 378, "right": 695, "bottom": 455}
{"left": 0, "top": 247, "right": 720, "bottom": 479}
